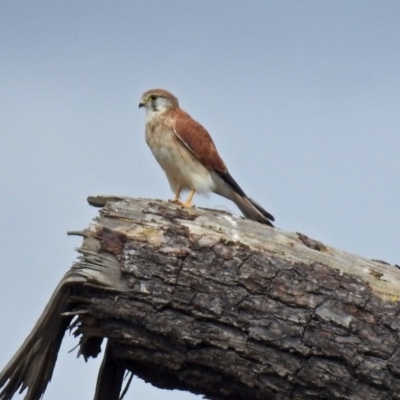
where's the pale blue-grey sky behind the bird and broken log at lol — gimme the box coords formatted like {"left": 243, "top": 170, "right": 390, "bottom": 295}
{"left": 0, "top": 0, "right": 400, "bottom": 400}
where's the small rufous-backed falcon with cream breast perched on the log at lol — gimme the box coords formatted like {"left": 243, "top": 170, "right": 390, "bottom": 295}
{"left": 139, "top": 89, "right": 275, "bottom": 227}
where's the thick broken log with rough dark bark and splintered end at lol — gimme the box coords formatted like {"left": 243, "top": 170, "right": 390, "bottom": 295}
{"left": 0, "top": 197, "right": 400, "bottom": 400}
